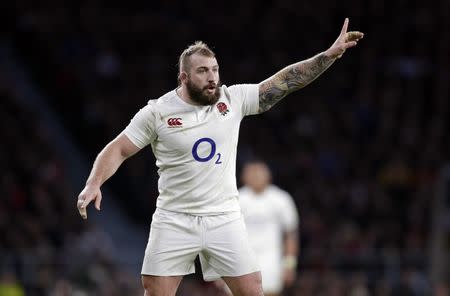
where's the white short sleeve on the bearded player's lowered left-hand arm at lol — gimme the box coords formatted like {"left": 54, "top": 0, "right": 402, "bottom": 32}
{"left": 123, "top": 104, "right": 156, "bottom": 149}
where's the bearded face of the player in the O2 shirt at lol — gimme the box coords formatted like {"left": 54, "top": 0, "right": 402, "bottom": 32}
{"left": 185, "top": 54, "right": 220, "bottom": 106}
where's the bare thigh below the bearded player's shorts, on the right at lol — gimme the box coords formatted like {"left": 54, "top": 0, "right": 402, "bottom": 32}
{"left": 223, "top": 271, "right": 264, "bottom": 296}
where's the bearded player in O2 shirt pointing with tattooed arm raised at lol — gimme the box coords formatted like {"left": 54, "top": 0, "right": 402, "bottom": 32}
{"left": 77, "top": 19, "right": 363, "bottom": 296}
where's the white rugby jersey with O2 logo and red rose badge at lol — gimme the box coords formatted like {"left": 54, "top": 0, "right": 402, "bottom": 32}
{"left": 124, "top": 84, "right": 259, "bottom": 215}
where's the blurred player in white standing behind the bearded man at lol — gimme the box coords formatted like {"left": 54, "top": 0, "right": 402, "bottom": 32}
{"left": 239, "top": 161, "right": 299, "bottom": 296}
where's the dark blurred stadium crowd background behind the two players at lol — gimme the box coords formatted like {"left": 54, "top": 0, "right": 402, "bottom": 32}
{"left": 0, "top": 0, "right": 450, "bottom": 296}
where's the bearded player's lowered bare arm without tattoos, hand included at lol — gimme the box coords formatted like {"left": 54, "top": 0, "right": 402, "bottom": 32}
{"left": 77, "top": 133, "right": 140, "bottom": 219}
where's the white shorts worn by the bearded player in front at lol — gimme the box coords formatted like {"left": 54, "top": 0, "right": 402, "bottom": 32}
{"left": 141, "top": 208, "right": 259, "bottom": 281}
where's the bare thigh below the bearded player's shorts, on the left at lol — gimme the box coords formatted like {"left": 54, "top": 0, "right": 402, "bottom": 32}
{"left": 142, "top": 275, "right": 183, "bottom": 296}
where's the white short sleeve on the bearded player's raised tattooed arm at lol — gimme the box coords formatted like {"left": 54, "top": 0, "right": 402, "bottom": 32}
{"left": 227, "top": 84, "right": 259, "bottom": 117}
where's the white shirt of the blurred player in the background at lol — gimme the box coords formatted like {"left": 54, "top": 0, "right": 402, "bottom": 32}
{"left": 239, "top": 185, "right": 299, "bottom": 262}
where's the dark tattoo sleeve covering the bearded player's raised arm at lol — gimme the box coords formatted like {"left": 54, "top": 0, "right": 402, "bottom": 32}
{"left": 259, "top": 53, "right": 335, "bottom": 113}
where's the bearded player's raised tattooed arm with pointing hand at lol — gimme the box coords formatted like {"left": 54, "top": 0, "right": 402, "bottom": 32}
{"left": 259, "top": 18, "right": 364, "bottom": 113}
